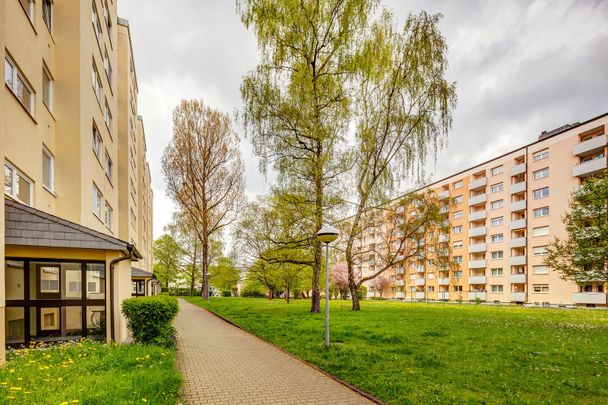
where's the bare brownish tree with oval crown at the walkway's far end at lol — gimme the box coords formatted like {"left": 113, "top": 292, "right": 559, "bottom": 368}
{"left": 162, "top": 100, "right": 244, "bottom": 298}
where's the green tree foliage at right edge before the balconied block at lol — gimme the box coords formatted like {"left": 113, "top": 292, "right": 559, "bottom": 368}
{"left": 545, "top": 170, "right": 608, "bottom": 284}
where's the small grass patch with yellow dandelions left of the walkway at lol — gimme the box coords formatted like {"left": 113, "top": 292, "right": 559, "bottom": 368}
{"left": 0, "top": 341, "right": 181, "bottom": 405}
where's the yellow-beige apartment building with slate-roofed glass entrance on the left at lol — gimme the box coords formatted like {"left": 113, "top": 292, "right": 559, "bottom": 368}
{"left": 0, "top": 0, "right": 155, "bottom": 360}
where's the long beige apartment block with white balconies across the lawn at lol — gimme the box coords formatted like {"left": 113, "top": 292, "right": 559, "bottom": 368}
{"left": 357, "top": 113, "right": 608, "bottom": 306}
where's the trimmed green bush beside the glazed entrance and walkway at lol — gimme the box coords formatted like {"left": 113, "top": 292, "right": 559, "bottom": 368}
{"left": 122, "top": 295, "right": 179, "bottom": 347}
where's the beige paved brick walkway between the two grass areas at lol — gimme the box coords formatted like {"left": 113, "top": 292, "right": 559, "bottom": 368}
{"left": 174, "top": 299, "right": 370, "bottom": 404}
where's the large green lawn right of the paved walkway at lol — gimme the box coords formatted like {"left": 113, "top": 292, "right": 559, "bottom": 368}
{"left": 189, "top": 298, "right": 608, "bottom": 404}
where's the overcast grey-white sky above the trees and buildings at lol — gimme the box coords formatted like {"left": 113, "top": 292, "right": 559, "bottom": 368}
{"left": 118, "top": 0, "right": 608, "bottom": 237}
